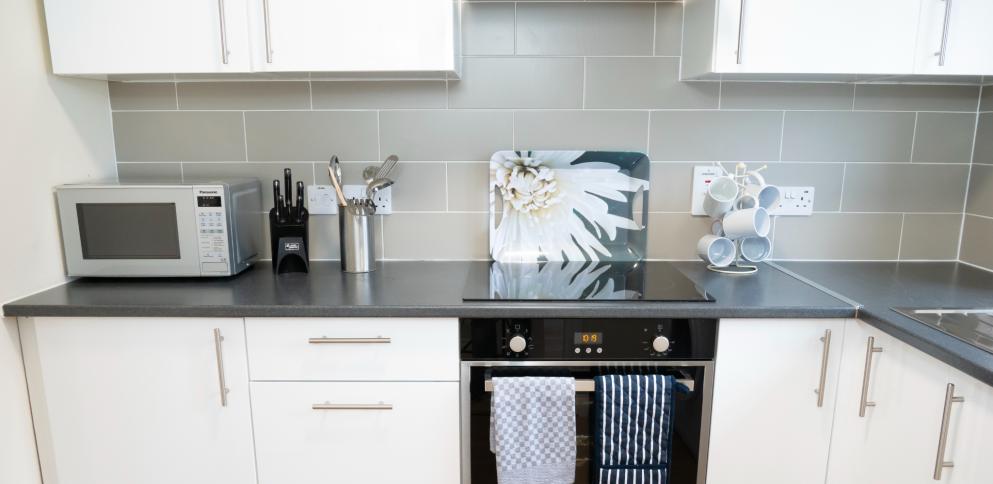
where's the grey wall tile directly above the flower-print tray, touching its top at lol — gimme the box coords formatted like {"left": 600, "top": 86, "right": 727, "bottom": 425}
{"left": 514, "top": 111, "right": 648, "bottom": 153}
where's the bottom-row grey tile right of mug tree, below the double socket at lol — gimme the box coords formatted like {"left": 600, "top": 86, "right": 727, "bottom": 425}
{"left": 773, "top": 213, "right": 903, "bottom": 260}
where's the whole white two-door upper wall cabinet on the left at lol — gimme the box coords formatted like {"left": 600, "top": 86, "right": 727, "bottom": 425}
{"left": 45, "top": 0, "right": 461, "bottom": 78}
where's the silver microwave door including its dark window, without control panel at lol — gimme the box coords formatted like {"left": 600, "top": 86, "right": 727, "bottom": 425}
{"left": 57, "top": 186, "right": 200, "bottom": 277}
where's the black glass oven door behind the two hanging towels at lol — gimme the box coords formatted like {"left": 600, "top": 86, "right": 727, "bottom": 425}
{"left": 461, "top": 361, "right": 714, "bottom": 484}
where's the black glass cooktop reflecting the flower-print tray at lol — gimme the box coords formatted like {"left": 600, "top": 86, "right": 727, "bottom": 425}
{"left": 462, "top": 261, "right": 714, "bottom": 302}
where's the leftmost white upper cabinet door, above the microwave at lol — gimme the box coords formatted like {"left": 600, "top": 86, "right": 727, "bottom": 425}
{"left": 45, "top": 0, "right": 250, "bottom": 75}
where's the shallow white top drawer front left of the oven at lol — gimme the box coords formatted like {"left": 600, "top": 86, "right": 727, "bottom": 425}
{"left": 246, "top": 318, "right": 459, "bottom": 381}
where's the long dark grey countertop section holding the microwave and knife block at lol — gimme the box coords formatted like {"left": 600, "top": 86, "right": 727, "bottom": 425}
{"left": 3, "top": 262, "right": 855, "bottom": 318}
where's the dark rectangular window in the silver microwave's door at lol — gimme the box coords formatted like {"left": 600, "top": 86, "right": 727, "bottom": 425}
{"left": 76, "top": 203, "right": 180, "bottom": 259}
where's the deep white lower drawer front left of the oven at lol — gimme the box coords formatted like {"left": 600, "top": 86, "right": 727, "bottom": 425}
{"left": 252, "top": 382, "right": 460, "bottom": 484}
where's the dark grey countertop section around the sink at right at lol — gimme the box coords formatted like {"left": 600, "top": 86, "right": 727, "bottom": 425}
{"left": 777, "top": 262, "right": 993, "bottom": 385}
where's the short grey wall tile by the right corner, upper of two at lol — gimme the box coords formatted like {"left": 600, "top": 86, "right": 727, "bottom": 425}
{"left": 913, "top": 113, "right": 976, "bottom": 163}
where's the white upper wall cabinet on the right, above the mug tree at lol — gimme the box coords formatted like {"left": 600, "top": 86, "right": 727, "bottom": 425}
{"left": 682, "top": 0, "right": 993, "bottom": 80}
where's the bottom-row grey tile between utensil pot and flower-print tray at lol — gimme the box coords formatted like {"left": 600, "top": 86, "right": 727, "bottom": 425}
{"left": 383, "top": 213, "right": 489, "bottom": 260}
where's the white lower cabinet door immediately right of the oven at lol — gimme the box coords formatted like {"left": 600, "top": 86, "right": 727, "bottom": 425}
{"left": 707, "top": 319, "right": 845, "bottom": 484}
